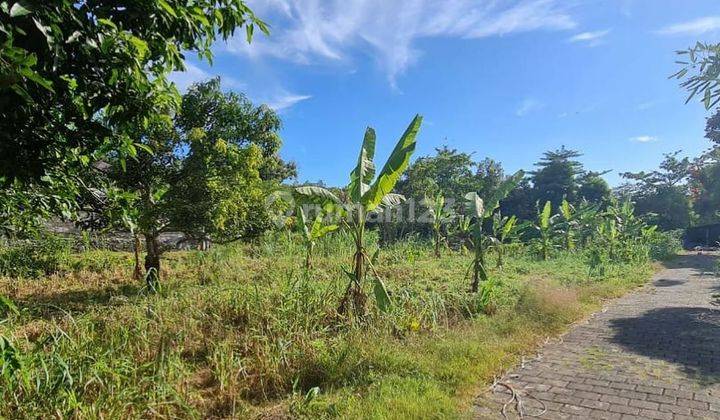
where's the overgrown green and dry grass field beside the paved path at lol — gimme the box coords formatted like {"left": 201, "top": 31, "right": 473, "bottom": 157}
{"left": 0, "top": 234, "right": 653, "bottom": 418}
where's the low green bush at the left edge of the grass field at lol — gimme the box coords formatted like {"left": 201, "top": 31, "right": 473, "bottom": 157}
{"left": 0, "top": 234, "right": 70, "bottom": 278}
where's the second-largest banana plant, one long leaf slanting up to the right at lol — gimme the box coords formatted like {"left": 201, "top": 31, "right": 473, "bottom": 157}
{"left": 465, "top": 171, "right": 525, "bottom": 292}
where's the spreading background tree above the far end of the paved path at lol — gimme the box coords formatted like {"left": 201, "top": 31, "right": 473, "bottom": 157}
{"left": 621, "top": 151, "right": 693, "bottom": 230}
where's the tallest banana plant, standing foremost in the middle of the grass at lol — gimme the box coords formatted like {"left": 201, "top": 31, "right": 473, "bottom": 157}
{"left": 295, "top": 115, "right": 422, "bottom": 315}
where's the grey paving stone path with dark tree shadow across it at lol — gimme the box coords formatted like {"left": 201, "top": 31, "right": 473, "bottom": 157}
{"left": 475, "top": 255, "right": 720, "bottom": 419}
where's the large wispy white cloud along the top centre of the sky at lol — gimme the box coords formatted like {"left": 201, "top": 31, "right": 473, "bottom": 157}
{"left": 226, "top": 0, "right": 576, "bottom": 85}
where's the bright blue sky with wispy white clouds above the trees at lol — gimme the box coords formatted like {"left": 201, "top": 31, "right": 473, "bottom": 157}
{"left": 167, "top": 0, "right": 720, "bottom": 185}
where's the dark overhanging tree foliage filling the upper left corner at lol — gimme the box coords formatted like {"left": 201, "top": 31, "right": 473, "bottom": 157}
{"left": 0, "top": 0, "right": 267, "bottom": 185}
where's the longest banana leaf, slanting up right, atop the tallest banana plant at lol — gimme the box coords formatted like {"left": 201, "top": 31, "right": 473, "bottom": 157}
{"left": 361, "top": 115, "right": 422, "bottom": 211}
